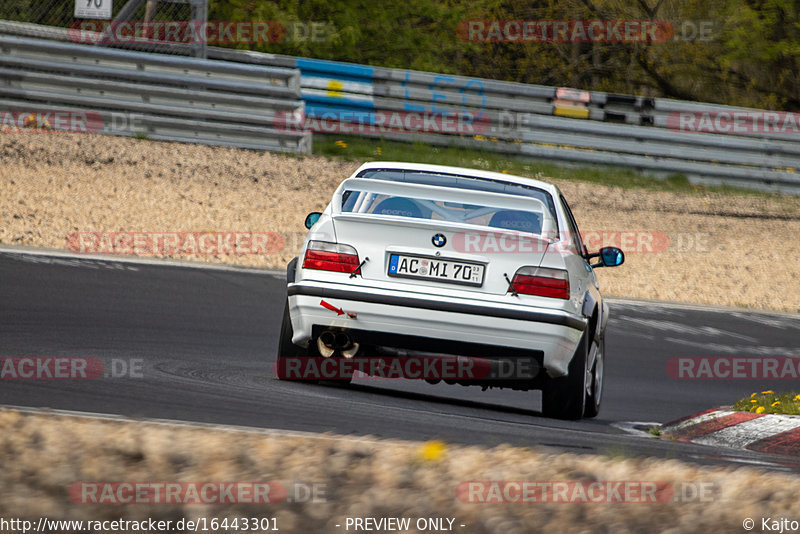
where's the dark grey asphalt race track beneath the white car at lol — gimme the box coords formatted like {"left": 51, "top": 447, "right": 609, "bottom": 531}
{"left": 0, "top": 252, "right": 800, "bottom": 471}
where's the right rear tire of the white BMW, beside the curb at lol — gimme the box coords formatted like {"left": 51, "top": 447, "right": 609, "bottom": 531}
{"left": 542, "top": 328, "right": 589, "bottom": 420}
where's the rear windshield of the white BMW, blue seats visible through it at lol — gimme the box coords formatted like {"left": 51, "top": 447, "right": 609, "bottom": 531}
{"left": 342, "top": 169, "right": 555, "bottom": 234}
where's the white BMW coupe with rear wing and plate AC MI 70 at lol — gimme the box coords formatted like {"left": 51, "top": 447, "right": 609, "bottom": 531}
{"left": 276, "top": 162, "right": 624, "bottom": 419}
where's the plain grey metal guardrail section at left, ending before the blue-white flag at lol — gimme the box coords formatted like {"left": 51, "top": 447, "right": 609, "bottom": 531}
{"left": 0, "top": 35, "right": 312, "bottom": 153}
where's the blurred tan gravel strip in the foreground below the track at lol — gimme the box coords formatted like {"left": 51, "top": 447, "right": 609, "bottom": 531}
{"left": 0, "top": 410, "right": 800, "bottom": 534}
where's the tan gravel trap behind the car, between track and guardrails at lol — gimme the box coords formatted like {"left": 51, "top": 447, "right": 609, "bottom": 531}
{"left": 0, "top": 134, "right": 800, "bottom": 312}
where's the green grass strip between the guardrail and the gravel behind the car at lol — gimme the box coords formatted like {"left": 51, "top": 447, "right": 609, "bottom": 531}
{"left": 313, "top": 134, "right": 774, "bottom": 196}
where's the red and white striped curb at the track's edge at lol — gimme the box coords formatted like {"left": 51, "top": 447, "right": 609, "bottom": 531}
{"left": 661, "top": 409, "right": 800, "bottom": 456}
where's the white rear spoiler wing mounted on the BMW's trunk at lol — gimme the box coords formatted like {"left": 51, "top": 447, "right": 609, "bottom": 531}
{"left": 331, "top": 178, "right": 558, "bottom": 236}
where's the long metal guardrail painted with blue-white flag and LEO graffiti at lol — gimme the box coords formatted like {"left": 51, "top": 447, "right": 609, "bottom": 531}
{"left": 0, "top": 21, "right": 800, "bottom": 194}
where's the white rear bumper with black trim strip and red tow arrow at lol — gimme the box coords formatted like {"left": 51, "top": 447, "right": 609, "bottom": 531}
{"left": 288, "top": 281, "right": 586, "bottom": 377}
